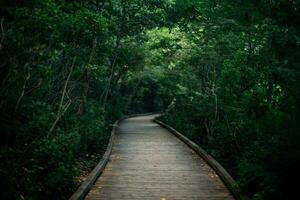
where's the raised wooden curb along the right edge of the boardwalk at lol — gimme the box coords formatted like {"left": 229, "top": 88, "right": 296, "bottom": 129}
{"left": 153, "top": 119, "right": 249, "bottom": 200}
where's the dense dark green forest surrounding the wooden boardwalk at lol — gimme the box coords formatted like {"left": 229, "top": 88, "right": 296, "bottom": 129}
{"left": 0, "top": 0, "right": 300, "bottom": 200}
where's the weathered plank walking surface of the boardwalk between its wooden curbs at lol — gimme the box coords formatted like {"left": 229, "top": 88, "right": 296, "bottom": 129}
{"left": 86, "top": 115, "right": 234, "bottom": 200}
